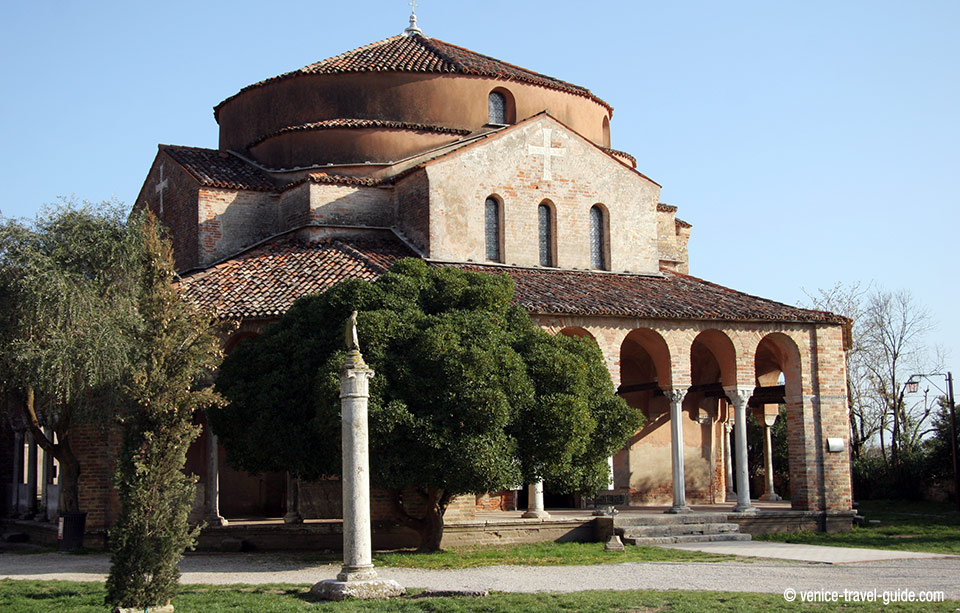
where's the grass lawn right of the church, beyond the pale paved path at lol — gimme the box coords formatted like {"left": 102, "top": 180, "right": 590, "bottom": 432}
{"left": 755, "top": 500, "right": 960, "bottom": 555}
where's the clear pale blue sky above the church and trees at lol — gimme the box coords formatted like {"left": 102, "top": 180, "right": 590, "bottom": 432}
{"left": 0, "top": 0, "right": 960, "bottom": 375}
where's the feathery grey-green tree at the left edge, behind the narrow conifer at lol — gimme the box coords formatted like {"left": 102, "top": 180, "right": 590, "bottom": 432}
{"left": 0, "top": 202, "right": 136, "bottom": 513}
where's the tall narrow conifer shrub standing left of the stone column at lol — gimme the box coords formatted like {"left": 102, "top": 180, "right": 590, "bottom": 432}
{"left": 106, "top": 212, "right": 221, "bottom": 608}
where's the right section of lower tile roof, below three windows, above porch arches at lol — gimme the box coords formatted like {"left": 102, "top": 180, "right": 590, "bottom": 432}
{"left": 438, "top": 264, "right": 846, "bottom": 324}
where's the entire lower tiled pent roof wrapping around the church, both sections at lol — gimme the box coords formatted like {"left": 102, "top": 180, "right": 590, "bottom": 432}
{"left": 181, "top": 238, "right": 846, "bottom": 324}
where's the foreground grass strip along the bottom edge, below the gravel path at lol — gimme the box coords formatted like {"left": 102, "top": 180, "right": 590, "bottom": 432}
{"left": 0, "top": 579, "right": 960, "bottom": 613}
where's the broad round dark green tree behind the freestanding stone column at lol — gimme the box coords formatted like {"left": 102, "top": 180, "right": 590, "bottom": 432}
{"left": 210, "top": 260, "right": 642, "bottom": 551}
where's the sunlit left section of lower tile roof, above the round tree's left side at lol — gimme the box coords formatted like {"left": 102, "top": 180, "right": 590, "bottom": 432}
{"left": 180, "top": 237, "right": 415, "bottom": 319}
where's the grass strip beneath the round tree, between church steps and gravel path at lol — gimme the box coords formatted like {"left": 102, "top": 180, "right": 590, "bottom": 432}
{"left": 374, "top": 543, "right": 737, "bottom": 568}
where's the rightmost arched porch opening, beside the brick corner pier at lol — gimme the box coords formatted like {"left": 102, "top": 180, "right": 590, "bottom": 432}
{"left": 747, "top": 332, "right": 816, "bottom": 509}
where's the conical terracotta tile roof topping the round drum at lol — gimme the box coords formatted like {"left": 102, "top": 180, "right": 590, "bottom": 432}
{"left": 214, "top": 35, "right": 613, "bottom": 115}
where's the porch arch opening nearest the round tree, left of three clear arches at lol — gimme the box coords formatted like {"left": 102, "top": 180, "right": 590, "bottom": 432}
{"left": 613, "top": 328, "right": 673, "bottom": 504}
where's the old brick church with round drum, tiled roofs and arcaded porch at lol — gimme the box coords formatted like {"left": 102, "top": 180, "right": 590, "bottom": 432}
{"left": 1, "top": 17, "right": 852, "bottom": 530}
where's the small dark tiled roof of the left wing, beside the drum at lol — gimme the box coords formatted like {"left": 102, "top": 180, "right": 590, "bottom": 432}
{"left": 159, "top": 145, "right": 277, "bottom": 191}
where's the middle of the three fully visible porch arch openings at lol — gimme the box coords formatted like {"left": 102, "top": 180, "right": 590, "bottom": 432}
{"left": 683, "top": 330, "right": 737, "bottom": 504}
